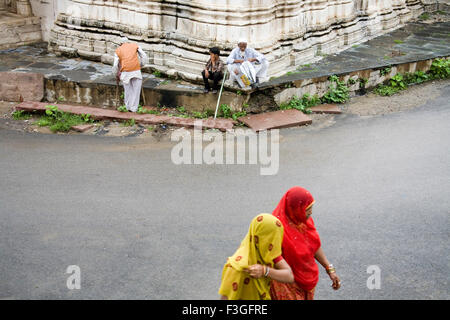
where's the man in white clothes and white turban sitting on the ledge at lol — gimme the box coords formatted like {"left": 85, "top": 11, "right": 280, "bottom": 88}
{"left": 227, "top": 39, "right": 269, "bottom": 88}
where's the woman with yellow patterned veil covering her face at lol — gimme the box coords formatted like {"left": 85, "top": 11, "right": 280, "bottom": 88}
{"left": 219, "top": 214, "right": 294, "bottom": 300}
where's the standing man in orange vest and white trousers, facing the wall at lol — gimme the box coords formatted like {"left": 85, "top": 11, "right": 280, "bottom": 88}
{"left": 113, "top": 38, "right": 148, "bottom": 112}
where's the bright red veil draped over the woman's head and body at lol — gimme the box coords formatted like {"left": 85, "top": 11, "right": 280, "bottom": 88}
{"left": 272, "top": 187, "right": 320, "bottom": 290}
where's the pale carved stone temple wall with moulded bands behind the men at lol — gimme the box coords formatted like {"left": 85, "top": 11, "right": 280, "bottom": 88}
{"left": 47, "top": 0, "right": 448, "bottom": 80}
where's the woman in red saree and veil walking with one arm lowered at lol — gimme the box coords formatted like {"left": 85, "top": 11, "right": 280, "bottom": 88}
{"left": 270, "top": 187, "right": 341, "bottom": 300}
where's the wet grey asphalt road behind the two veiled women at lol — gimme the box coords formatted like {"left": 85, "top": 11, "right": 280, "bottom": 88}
{"left": 0, "top": 86, "right": 450, "bottom": 299}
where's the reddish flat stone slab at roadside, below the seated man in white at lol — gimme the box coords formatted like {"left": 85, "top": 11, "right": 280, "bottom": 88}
{"left": 238, "top": 109, "right": 312, "bottom": 132}
